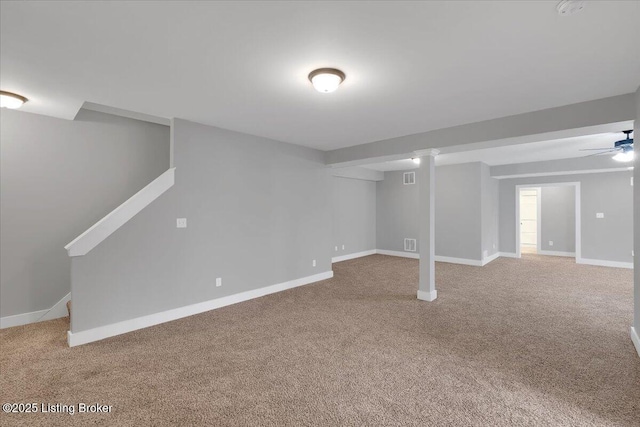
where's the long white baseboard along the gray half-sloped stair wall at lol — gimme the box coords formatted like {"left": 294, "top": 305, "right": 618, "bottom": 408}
{"left": 67, "top": 271, "right": 333, "bottom": 347}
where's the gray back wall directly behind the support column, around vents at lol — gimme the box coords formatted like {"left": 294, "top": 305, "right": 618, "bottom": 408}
{"left": 377, "top": 162, "right": 498, "bottom": 260}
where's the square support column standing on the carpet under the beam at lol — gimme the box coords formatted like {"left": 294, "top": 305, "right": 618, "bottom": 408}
{"left": 414, "top": 149, "right": 439, "bottom": 301}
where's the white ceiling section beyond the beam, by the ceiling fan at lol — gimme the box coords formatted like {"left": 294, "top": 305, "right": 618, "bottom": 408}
{"left": 362, "top": 133, "right": 633, "bottom": 172}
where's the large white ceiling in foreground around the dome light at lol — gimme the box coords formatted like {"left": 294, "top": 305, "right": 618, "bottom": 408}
{"left": 0, "top": 0, "right": 640, "bottom": 150}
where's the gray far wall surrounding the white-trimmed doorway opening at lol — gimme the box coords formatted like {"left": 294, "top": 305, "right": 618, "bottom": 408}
{"left": 499, "top": 171, "right": 633, "bottom": 262}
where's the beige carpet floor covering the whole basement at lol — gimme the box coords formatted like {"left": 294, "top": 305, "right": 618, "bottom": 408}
{"left": 0, "top": 255, "right": 640, "bottom": 426}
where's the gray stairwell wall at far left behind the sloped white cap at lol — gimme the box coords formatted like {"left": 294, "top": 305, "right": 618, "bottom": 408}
{"left": 0, "top": 108, "right": 169, "bottom": 317}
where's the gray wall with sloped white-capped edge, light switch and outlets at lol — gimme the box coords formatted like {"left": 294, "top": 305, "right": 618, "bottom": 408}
{"left": 71, "top": 120, "right": 333, "bottom": 332}
